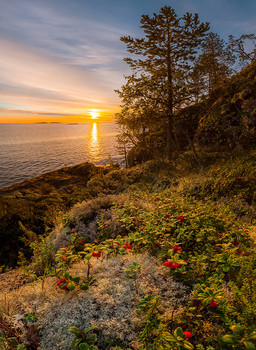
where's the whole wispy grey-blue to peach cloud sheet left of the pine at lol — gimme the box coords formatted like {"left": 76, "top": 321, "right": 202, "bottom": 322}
{"left": 0, "top": 0, "right": 129, "bottom": 119}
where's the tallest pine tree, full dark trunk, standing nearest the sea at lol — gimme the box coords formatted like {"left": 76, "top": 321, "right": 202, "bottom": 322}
{"left": 117, "top": 6, "right": 209, "bottom": 160}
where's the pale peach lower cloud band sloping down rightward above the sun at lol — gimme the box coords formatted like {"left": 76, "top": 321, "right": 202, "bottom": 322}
{"left": 0, "top": 38, "right": 123, "bottom": 115}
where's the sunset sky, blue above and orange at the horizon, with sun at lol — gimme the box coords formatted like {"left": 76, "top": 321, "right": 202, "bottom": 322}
{"left": 0, "top": 0, "right": 256, "bottom": 123}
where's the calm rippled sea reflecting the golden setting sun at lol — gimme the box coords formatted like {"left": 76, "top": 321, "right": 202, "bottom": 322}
{"left": 0, "top": 123, "right": 121, "bottom": 188}
